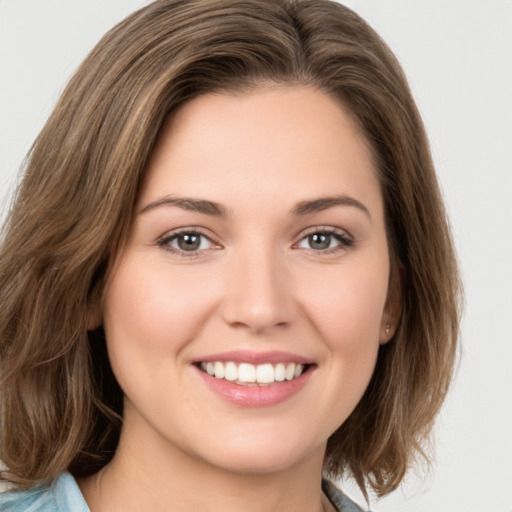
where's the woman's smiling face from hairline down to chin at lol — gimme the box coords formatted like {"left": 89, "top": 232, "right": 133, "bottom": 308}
{"left": 103, "top": 86, "right": 393, "bottom": 472}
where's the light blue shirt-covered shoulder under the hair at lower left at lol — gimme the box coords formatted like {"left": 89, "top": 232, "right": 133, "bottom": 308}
{"left": 0, "top": 473, "right": 90, "bottom": 512}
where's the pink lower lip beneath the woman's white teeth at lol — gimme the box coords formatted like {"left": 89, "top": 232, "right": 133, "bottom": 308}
{"left": 196, "top": 367, "right": 313, "bottom": 407}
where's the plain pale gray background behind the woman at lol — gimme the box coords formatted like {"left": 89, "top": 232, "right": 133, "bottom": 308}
{"left": 0, "top": 0, "right": 512, "bottom": 512}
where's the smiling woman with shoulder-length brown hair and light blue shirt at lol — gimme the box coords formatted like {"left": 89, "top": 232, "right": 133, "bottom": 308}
{"left": 0, "top": 0, "right": 458, "bottom": 512}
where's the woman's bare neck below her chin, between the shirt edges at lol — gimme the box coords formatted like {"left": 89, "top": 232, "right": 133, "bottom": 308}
{"left": 79, "top": 414, "right": 331, "bottom": 512}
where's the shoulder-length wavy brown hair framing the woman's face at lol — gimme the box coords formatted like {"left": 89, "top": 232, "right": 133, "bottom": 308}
{"left": 0, "top": 0, "right": 460, "bottom": 495}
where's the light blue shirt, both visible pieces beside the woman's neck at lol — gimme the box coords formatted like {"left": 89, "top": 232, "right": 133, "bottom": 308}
{"left": 0, "top": 473, "right": 361, "bottom": 512}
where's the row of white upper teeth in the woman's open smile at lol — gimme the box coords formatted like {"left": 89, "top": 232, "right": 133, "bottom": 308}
{"left": 200, "top": 361, "right": 304, "bottom": 384}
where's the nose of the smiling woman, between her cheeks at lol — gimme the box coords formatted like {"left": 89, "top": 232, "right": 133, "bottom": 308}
{"left": 222, "top": 248, "right": 296, "bottom": 334}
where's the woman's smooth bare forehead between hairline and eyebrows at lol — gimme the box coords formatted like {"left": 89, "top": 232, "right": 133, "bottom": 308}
{"left": 140, "top": 86, "right": 381, "bottom": 218}
